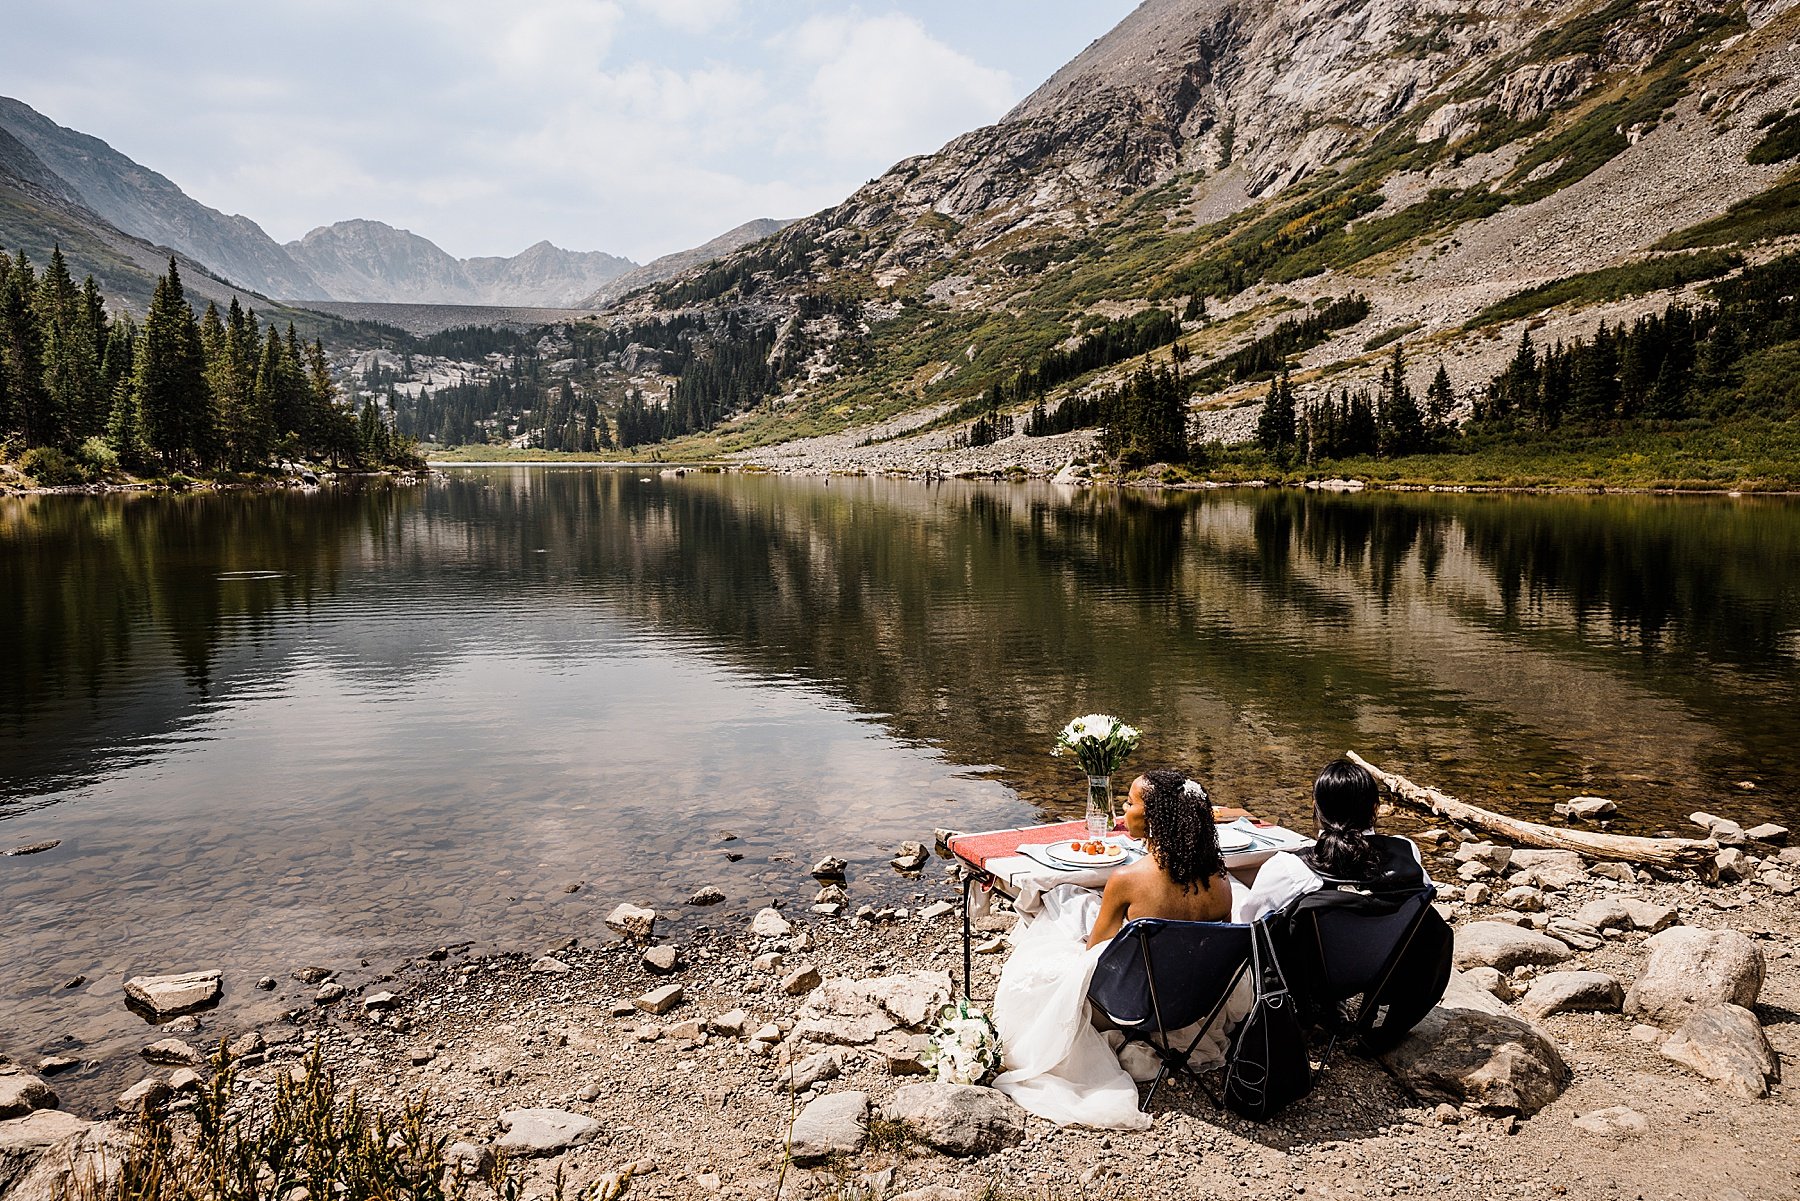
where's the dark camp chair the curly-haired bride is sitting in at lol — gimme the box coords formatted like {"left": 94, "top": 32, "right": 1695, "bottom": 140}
{"left": 1087, "top": 918, "right": 1249, "bottom": 1109}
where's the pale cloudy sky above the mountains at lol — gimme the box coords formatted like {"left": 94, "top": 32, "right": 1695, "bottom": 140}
{"left": 0, "top": 0, "right": 1136, "bottom": 261}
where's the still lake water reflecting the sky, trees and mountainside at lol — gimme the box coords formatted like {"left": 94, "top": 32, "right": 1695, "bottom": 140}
{"left": 0, "top": 468, "right": 1800, "bottom": 1107}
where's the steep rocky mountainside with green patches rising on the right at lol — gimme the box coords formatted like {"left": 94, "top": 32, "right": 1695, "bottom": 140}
{"left": 614, "top": 0, "right": 1800, "bottom": 464}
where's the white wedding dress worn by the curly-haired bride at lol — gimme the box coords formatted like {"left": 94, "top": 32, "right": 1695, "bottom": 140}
{"left": 994, "top": 884, "right": 1253, "bottom": 1131}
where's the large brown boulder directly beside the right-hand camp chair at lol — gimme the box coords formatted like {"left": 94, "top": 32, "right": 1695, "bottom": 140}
{"left": 1382, "top": 972, "right": 1570, "bottom": 1115}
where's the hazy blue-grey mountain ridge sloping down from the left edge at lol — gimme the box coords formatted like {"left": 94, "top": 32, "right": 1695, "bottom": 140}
{"left": 0, "top": 97, "right": 317, "bottom": 297}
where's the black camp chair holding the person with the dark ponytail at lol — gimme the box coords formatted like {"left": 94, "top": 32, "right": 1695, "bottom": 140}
{"left": 1276, "top": 884, "right": 1451, "bottom": 1068}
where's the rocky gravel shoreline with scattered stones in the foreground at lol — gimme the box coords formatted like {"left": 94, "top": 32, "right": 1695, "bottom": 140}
{"left": 0, "top": 816, "right": 1800, "bottom": 1201}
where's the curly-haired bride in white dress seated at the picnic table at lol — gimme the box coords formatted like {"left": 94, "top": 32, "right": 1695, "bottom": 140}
{"left": 994, "top": 771, "right": 1251, "bottom": 1131}
